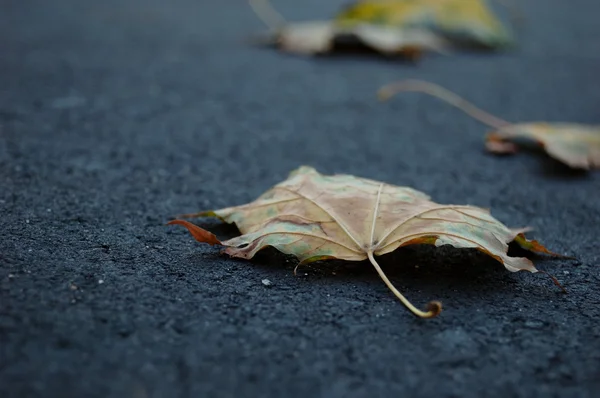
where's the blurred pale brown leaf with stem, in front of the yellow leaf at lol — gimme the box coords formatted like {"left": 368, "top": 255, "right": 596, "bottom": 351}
{"left": 250, "top": 0, "right": 448, "bottom": 58}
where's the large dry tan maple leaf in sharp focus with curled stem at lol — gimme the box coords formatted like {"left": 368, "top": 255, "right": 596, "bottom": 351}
{"left": 169, "top": 166, "right": 558, "bottom": 318}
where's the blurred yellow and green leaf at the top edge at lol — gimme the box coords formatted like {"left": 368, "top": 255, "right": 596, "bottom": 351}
{"left": 335, "top": 0, "right": 513, "bottom": 48}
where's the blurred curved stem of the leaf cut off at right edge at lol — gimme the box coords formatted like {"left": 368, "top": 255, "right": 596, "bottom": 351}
{"left": 377, "top": 79, "right": 513, "bottom": 129}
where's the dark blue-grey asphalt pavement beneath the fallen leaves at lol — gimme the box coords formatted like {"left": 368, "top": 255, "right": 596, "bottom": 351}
{"left": 0, "top": 0, "right": 600, "bottom": 398}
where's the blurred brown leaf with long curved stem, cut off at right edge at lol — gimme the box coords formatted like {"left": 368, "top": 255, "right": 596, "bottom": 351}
{"left": 378, "top": 80, "right": 600, "bottom": 170}
